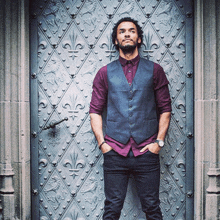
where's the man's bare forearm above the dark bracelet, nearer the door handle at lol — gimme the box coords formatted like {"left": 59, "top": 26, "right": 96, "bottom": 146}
{"left": 90, "top": 113, "right": 104, "bottom": 145}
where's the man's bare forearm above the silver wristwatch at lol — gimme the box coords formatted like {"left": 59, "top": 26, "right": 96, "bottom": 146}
{"left": 157, "top": 112, "right": 171, "bottom": 141}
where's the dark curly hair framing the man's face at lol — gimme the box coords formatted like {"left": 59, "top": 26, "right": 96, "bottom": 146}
{"left": 112, "top": 17, "right": 143, "bottom": 50}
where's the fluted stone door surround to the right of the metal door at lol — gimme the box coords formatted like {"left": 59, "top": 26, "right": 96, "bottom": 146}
{"left": 194, "top": 0, "right": 220, "bottom": 220}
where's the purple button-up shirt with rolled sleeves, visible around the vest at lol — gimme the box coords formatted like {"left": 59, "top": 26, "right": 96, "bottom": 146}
{"left": 89, "top": 55, "right": 171, "bottom": 157}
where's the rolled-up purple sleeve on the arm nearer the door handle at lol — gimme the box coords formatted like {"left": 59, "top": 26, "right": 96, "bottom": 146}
{"left": 89, "top": 66, "right": 108, "bottom": 115}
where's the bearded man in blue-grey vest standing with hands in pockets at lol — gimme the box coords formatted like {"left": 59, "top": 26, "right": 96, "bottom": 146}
{"left": 90, "top": 18, "right": 171, "bottom": 220}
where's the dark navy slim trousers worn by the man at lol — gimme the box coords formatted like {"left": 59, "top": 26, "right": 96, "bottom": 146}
{"left": 103, "top": 150, "right": 162, "bottom": 220}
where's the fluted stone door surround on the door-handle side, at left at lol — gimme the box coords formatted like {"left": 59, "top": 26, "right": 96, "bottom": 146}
{"left": 0, "top": 0, "right": 31, "bottom": 220}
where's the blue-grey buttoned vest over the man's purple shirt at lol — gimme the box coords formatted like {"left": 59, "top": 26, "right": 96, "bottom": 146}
{"left": 106, "top": 58, "right": 158, "bottom": 144}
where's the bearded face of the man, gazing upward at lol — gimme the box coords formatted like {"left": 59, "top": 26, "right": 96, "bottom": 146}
{"left": 115, "top": 21, "right": 141, "bottom": 49}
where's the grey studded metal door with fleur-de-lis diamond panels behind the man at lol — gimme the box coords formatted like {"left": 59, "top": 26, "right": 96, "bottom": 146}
{"left": 30, "top": 0, "right": 193, "bottom": 220}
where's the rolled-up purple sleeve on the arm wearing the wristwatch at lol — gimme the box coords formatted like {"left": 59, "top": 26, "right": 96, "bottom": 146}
{"left": 154, "top": 63, "right": 172, "bottom": 114}
